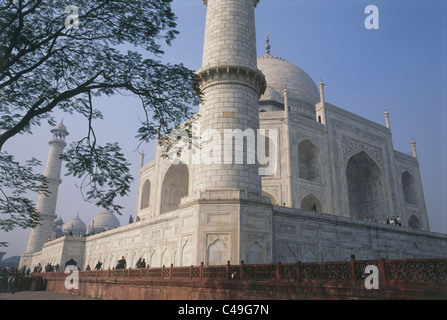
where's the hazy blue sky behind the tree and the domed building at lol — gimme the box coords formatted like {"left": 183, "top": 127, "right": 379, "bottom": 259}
{"left": 0, "top": 0, "right": 447, "bottom": 258}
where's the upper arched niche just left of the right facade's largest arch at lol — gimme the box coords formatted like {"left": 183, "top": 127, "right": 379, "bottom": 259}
{"left": 298, "top": 140, "right": 320, "bottom": 182}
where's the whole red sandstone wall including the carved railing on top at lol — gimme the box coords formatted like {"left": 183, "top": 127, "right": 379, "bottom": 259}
{"left": 35, "top": 256, "right": 447, "bottom": 300}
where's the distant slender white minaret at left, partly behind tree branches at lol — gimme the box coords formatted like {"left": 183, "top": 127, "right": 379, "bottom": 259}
{"left": 26, "top": 122, "right": 68, "bottom": 253}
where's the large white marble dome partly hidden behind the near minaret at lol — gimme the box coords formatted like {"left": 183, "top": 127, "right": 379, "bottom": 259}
{"left": 258, "top": 54, "right": 320, "bottom": 105}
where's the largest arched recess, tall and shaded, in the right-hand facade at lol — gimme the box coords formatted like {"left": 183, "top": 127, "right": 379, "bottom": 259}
{"left": 346, "top": 151, "right": 387, "bottom": 220}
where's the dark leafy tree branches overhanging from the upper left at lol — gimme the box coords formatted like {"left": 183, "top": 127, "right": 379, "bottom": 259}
{"left": 0, "top": 0, "right": 200, "bottom": 235}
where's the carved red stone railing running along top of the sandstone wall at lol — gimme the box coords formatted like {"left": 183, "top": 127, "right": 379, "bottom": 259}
{"left": 31, "top": 256, "right": 447, "bottom": 288}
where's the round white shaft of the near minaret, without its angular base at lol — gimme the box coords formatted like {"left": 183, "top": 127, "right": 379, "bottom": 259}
{"left": 194, "top": 0, "right": 266, "bottom": 194}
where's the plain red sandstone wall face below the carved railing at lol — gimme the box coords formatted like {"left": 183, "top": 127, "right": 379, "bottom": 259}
{"left": 42, "top": 277, "right": 447, "bottom": 300}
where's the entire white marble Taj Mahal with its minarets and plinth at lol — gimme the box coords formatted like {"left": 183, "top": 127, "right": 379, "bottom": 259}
{"left": 20, "top": 0, "right": 447, "bottom": 270}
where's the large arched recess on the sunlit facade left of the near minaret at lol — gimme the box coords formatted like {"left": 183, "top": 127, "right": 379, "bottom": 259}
{"left": 160, "top": 163, "right": 189, "bottom": 213}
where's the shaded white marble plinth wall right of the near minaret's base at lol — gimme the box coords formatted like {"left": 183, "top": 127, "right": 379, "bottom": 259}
{"left": 273, "top": 208, "right": 447, "bottom": 263}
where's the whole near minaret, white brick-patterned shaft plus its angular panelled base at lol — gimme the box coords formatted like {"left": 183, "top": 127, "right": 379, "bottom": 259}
{"left": 190, "top": 0, "right": 272, "bottom": 265}
